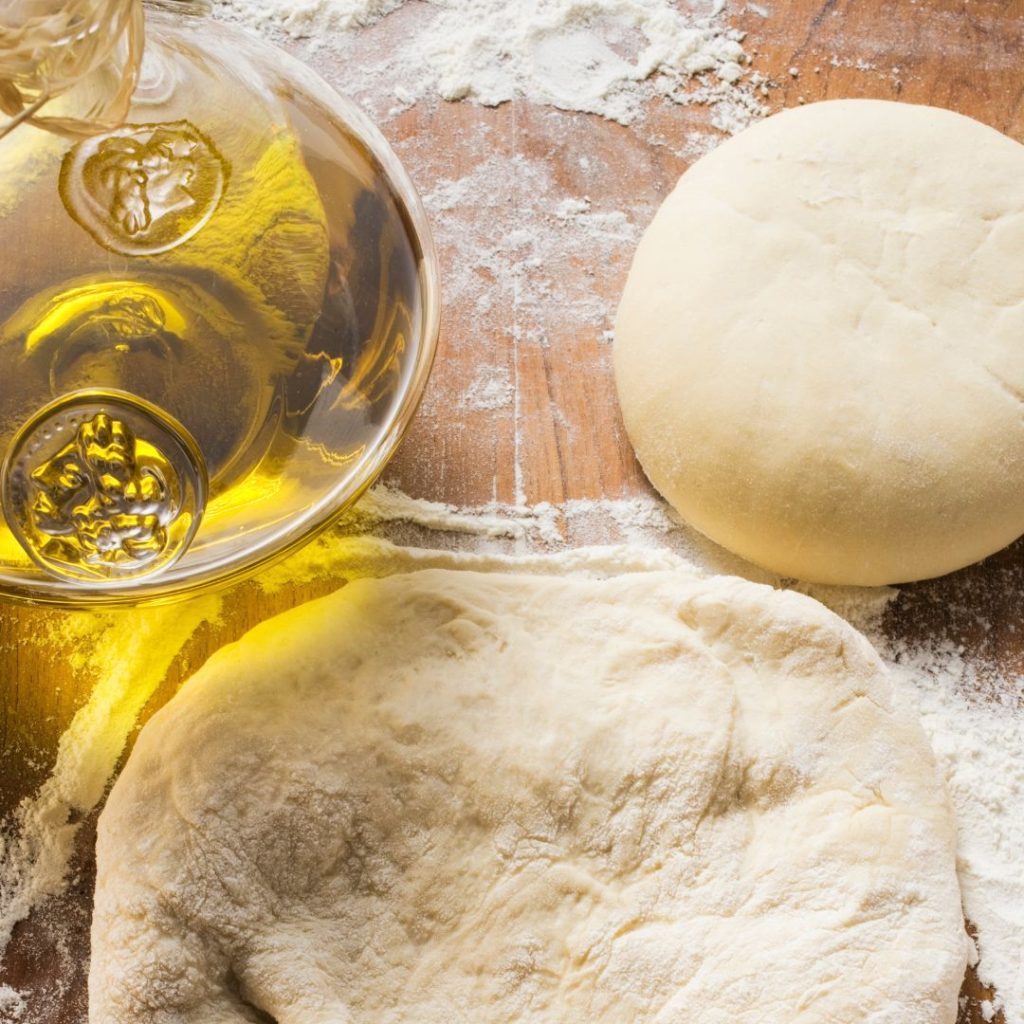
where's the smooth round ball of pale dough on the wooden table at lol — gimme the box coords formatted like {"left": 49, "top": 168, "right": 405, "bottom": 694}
{"left": 614, "top": 100, "right": 1024, "bottom": 586}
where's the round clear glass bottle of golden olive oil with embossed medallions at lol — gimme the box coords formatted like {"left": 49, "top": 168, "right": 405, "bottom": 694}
{"left": 0, "top": 0, "right": 437, "bottom": 603}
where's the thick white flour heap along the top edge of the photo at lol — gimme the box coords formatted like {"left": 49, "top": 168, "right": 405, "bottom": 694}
{"left": 217, "top": 0, "right": 760, "bottom": 130}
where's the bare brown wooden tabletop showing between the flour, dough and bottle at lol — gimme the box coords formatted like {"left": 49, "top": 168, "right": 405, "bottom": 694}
{"left": 0, "top": 0, "right": 1024, "bottom": 1024}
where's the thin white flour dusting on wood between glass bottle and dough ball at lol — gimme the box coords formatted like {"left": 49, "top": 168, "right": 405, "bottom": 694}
{"left": 403, "top": 149, "right": 638, "bottom": 504}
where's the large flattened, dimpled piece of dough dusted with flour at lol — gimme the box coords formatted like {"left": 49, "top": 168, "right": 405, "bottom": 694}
{"left": 89, "top": 570, "right": 967, "bottom": 1024}
